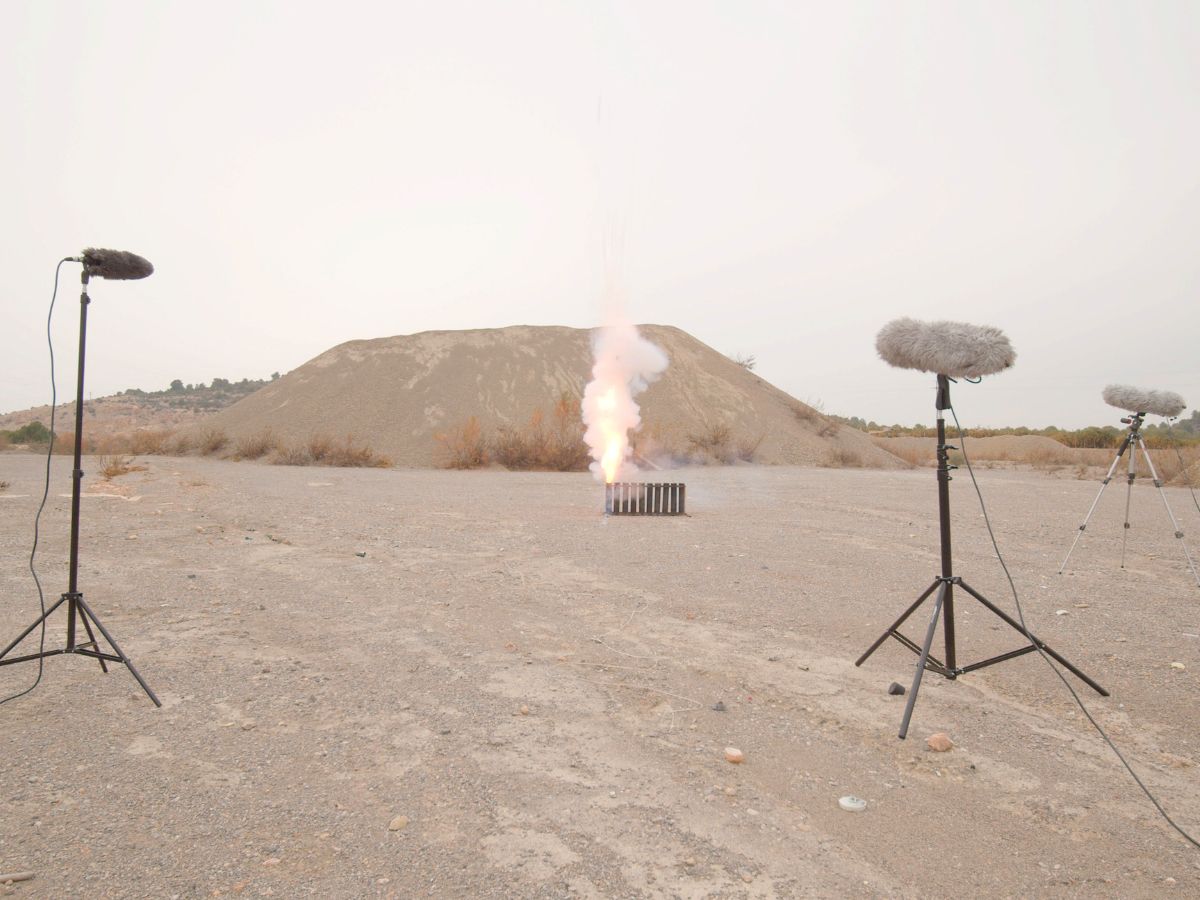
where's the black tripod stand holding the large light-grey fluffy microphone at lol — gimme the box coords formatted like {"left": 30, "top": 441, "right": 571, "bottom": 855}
{"left": 854, "top": 374, "right": 1109, "bottom": 740}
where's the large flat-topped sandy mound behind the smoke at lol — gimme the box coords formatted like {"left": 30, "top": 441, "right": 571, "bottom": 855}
{"left": 196, "top": 325, "right": 900, "bottom": 467}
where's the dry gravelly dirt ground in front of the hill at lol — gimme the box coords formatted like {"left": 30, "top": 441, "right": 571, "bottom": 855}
{"left": 0, "top": 454, "right": 1200, "bottom": 898}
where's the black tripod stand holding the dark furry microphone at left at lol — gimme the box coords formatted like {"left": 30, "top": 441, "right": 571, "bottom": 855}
{"left": 0, "top": 268, "right": 162, "bottom": 707}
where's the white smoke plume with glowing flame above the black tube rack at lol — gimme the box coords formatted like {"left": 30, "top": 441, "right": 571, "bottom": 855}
{"left": 583, "top": 319, "right": 670, "bottom": 482}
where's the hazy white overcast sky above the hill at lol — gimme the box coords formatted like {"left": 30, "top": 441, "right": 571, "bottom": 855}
{"left": 0, "top": 0, "right": 1200, "bottom": 426}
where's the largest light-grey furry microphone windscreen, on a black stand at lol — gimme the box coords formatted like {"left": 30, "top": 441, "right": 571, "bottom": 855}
{"left": 875, "top": 318, "right": 1016, "bottom": 378}
